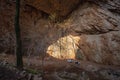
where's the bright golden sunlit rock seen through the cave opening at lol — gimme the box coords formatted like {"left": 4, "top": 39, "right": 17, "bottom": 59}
{"left": 47, "top": 35, "right": 80, "bottom": 59}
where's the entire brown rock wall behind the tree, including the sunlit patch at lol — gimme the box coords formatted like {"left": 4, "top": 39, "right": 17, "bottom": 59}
{"left": 0, "top": 0, "right": 120, "bottom": 65}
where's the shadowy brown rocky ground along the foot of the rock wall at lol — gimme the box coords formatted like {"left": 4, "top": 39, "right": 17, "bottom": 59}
{"left": 0, "top": 54, "right": 120, "bottom": 80}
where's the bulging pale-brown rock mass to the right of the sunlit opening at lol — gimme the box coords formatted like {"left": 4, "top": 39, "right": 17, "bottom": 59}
{"left": 67, "top": 3, "right": 120, "bottom": 65}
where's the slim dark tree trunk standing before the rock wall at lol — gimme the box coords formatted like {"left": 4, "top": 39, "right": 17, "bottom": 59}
{"left": 15, "top": 0, "right": 23, "bottom": 69}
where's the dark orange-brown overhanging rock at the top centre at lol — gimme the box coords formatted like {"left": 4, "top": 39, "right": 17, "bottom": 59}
{"left": 26, "top": 0, "right": 81, "bottom": 16}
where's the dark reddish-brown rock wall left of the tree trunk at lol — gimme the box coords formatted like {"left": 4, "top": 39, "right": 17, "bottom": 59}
{"left": 0, "top": 0, "right": 15, "bottom": 52}
